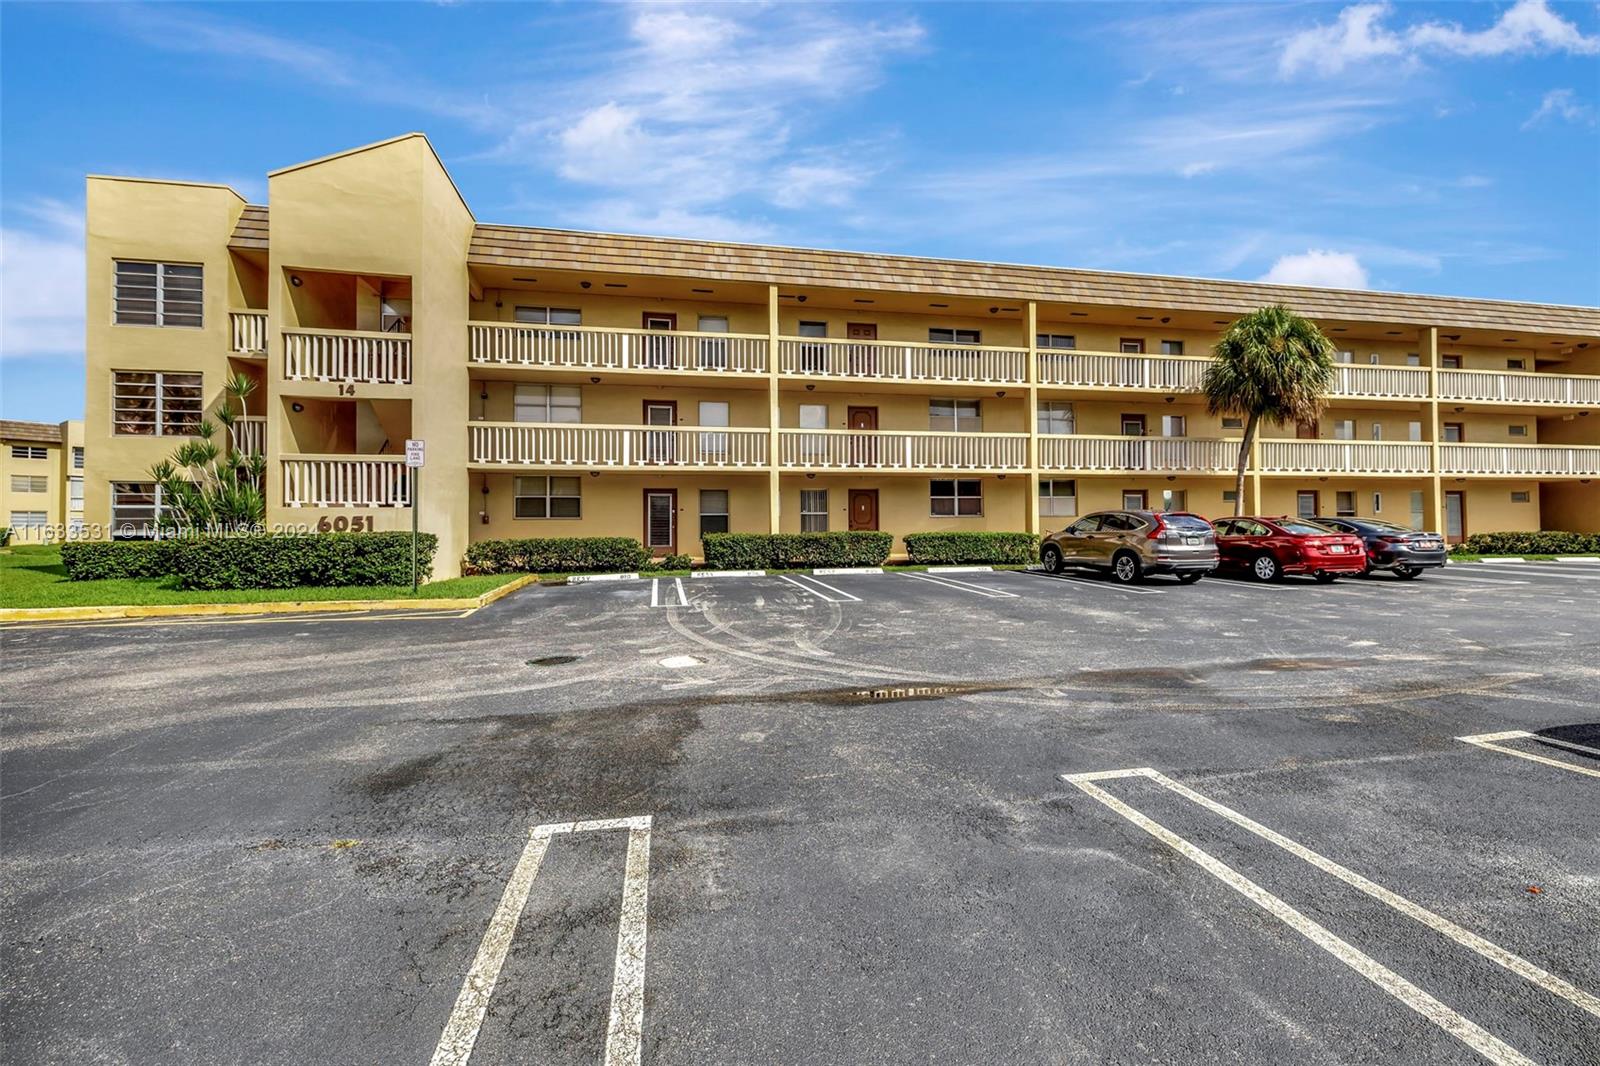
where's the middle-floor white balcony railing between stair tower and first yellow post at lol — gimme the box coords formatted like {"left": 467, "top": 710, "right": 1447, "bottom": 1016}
{"left": 469, "top": 423, "right": 768, "bottom": 469}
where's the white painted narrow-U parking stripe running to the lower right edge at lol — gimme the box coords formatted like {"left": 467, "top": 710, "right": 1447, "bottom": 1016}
{"left": 1061, "top": 767, "right": 1600, "bottom": 1030}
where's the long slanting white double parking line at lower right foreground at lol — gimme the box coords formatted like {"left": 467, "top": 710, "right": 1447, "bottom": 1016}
{"left": 1061, "top": 767, "right": 1600, "bottom": 1064}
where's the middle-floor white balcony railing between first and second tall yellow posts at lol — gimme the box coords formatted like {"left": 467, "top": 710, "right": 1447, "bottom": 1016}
{"left": 778, "top": 429, "right": 1027, "bottom": 471}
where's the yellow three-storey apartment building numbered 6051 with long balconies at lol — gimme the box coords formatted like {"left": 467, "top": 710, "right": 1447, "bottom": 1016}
{"left": 85, "top": 134, "right": 1600, "bottom": 576}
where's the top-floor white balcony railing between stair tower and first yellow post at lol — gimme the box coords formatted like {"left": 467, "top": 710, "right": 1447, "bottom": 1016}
{"left": 467, "top": 322, "right": 766, "bottom": 373}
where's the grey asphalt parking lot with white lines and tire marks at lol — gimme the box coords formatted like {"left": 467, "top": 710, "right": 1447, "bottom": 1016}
{"left": 0, "top": 562, "right": 1600, "bottom": 1066}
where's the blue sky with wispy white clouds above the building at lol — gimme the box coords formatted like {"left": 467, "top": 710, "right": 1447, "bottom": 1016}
{"left": 0, "top": 0, "right": 1600, "bottom": 421}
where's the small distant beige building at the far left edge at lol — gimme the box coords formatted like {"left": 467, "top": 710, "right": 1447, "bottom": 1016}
{"left": 0, "top": 419, "right": 85, "bottom": 544}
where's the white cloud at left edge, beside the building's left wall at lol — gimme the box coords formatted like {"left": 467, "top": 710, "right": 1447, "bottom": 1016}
{"left": 0, "top": 200, "right": 83, "bottom": 360}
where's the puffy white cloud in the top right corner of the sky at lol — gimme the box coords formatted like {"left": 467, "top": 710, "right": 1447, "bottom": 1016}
{"left": 1278, "top": 0, "right": 1600, "bottom": 75}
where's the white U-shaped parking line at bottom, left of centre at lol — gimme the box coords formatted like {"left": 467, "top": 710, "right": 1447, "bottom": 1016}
{"left": 430, "top": 815, "right": 651, "bottom": 1066}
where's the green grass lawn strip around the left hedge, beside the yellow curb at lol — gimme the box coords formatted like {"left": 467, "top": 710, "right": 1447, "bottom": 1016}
{"left": 0, "top": 544, "right": 522, "bottom": 607}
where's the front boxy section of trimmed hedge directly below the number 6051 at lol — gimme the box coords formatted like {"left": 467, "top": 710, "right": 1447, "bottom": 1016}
{"left": 168, "top": 531, "right": 438, "bottom": 589}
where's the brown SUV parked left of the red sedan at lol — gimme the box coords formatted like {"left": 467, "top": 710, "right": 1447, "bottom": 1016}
{"left": 1038, "top": 511, "right": 1218, "bottom": 584}
